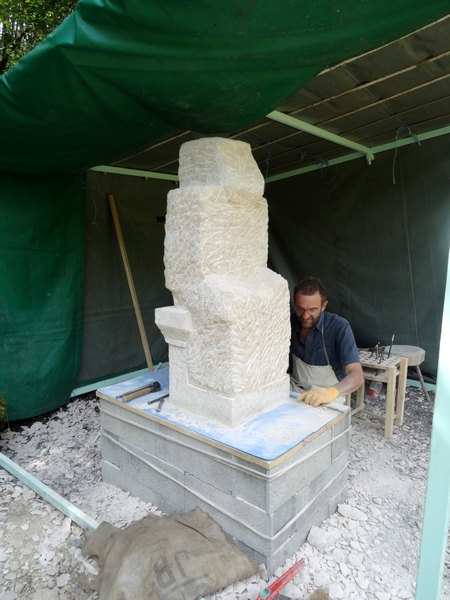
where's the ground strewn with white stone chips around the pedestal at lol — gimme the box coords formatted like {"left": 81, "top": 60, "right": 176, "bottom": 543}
{"left": 0, "top": 387, "right": 450, "bottom": 600}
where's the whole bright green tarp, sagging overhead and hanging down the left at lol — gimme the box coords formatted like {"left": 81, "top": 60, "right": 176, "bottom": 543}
{"left": 0, "top": 0, "right": 448, "bottom": 420}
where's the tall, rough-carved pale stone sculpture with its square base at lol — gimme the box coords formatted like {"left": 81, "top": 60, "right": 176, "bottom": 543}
{"left": 156, "top": 138, "right": 290, "bottom": 426}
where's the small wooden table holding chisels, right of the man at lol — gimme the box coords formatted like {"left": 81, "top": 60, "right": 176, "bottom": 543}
{"left": 352, "top": 350, "right": 408, "bottom": 438}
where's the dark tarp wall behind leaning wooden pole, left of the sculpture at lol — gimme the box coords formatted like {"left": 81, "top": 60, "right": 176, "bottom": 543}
{"left": 77, "top": 171, "right": 174, "bottom": 385}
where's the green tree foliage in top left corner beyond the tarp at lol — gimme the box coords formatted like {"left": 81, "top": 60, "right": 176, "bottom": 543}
{"left": 0, "top": 0, "right": 77, "bottom": 75}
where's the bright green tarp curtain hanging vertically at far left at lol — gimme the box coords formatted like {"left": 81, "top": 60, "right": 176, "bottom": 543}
{"left": 0, "top": 173, "right": 85, "bottom": 421}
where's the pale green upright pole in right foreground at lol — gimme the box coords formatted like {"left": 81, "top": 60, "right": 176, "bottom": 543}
{"left": 416, "top": 251, "right": 450, "bottom": 600}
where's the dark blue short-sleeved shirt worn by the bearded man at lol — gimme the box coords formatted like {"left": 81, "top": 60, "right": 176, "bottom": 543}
{"left": 291, "top": 311, "right": 360, "bottom": 381}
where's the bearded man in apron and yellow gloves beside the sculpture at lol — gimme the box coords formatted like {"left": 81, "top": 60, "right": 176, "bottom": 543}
{"left": 291, "top": 277, "right": 364, "bottom": 406}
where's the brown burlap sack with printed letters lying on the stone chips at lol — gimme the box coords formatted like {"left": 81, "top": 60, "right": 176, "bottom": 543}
{"left": 82, "top": 508, "right": 258, "bottom": 600}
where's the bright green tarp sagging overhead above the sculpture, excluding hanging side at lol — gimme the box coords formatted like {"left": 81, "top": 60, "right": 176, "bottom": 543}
{"left": 0, "top": 0, "right": 448, "bottom": 173}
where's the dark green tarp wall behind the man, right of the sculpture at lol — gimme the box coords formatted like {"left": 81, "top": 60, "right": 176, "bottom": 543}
{"left": 265, "top": 136, "right": 450, "bottom": 381}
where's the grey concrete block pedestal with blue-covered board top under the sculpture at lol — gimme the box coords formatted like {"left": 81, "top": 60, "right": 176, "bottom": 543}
{"left": 97, "top": 369, "right": 350, "bottom": 574}
